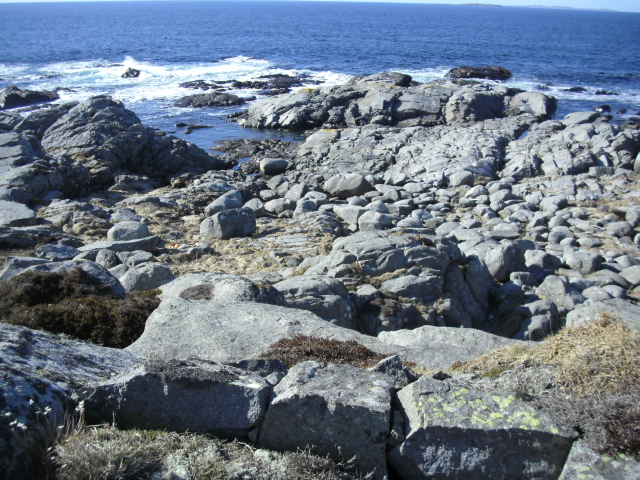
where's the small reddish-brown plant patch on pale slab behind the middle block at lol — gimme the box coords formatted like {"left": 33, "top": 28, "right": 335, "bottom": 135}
{"left": 255, "top": 335, "right": 385, "bottom": 368}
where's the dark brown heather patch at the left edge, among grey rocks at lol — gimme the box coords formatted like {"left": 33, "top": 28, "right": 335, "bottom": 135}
{"left": 0, "top": 268, "right": 160, "bottom": 348}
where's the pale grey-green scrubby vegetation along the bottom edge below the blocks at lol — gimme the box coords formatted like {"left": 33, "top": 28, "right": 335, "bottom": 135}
{"left": 53, "top": 425, "right": 356, "bottom": 480}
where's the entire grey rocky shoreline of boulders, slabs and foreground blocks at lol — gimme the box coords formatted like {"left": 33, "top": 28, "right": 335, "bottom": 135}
{"left": 0, "top": 72, "right": 640, "bottom": 480}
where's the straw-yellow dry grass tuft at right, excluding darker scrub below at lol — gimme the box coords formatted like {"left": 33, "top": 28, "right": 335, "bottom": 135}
{"left": 451, "top": 314, "right": 640, "bottom": 396}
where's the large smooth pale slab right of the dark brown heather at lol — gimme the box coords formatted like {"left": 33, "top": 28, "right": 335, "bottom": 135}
{"left": 127, "top": 298, "right": 394, "bottom": 363}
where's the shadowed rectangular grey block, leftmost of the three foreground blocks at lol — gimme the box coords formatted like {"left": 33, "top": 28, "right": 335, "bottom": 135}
{"left": 85, "top": 360, "right": 271, "bottom": 438}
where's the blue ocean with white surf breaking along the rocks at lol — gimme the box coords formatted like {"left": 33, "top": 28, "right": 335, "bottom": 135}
{"left": 0, "top": 1, "right": 640, "bottom": 148}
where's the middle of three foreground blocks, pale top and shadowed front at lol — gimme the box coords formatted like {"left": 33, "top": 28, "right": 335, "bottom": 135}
{"left": 257, "top": 362, "right": 393, "bottom": 479}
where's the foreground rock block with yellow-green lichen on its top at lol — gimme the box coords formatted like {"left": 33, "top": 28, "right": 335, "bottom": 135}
{"left": 389, "top": 376, "right": 573, "bottom": 479}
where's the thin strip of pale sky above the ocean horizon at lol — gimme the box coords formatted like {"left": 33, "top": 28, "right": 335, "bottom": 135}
{"left": 0, "top": 0, "right": 640, "bottom": 12}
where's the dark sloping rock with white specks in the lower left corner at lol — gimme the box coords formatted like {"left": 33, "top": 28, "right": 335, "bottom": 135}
{"left": 0, "top": 323, "right": 138, "bottom": 478}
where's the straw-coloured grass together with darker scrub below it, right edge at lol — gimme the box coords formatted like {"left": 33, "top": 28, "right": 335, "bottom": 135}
{"left": 450, "top": 314, "right": 640, "bottom": 460}
